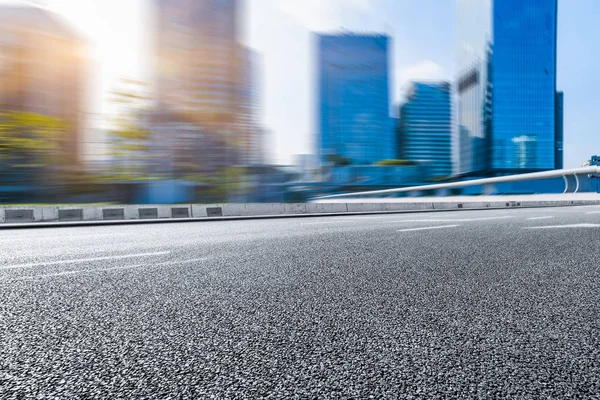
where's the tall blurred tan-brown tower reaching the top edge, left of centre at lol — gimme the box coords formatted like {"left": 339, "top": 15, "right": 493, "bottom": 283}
{"left": 153, "top": 0, "right": 247, "bottom": 173}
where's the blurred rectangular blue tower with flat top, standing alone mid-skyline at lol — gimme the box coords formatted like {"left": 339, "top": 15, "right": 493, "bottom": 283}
{"left": 317, "top": 33, "right": 396, "bottom": 164}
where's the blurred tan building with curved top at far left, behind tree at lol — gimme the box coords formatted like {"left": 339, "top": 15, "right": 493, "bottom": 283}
{"left": 0, "top": 5, "right": 87, "bottom": 167}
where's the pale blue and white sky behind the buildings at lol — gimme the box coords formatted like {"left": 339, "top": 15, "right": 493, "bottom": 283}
{"left": 0, "top": 0, "right": 600, "bottom": 168}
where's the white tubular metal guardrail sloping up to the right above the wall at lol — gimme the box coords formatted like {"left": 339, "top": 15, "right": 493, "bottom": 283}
{"left": 316, "top": 166, "right": 600, "bottom": 200}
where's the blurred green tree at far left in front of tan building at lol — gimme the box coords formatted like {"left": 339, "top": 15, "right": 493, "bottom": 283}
{"left": 0, "top": 111, "right": 69, "bottom": 185}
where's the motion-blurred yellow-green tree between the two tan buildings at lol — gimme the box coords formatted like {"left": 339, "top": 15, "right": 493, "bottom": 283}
{"left": 108, "top": 78, "right": 151, "bottom": 180}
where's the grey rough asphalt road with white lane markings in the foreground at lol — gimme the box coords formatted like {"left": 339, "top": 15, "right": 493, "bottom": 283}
{"left": 0, "top": 206, "right": 600, "bottom": 399}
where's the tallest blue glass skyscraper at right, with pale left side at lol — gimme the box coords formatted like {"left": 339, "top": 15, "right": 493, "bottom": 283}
{"left": 455, "top": 0, "right": 562, "bottom": 175}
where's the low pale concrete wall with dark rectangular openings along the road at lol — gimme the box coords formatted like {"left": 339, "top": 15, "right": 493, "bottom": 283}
{"left": 0, "top": 194, "right": 600, "bottom": 224}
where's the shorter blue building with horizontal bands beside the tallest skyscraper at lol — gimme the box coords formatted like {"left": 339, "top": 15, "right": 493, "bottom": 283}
{"left": 398, "top": 82, "right": 452, "bottom": 177}
